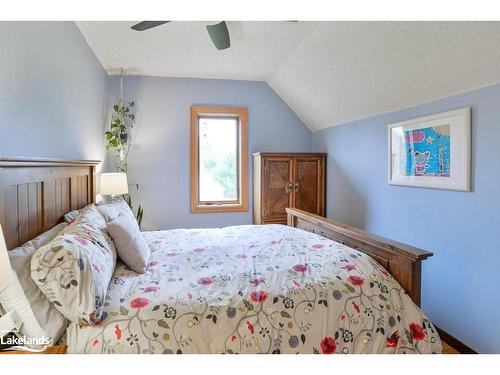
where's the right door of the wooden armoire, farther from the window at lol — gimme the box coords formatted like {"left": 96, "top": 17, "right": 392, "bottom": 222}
{"left": 292, "top": 156, "right": 325, "bottom": 216}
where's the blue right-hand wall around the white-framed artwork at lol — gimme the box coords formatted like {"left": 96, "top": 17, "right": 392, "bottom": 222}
{"left": 313, "top": 85, "right": 500, "bottom": 353}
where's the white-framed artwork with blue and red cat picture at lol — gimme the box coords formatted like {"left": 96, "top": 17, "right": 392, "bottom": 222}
{"left": 388, "top": 107, "right": 470, "bottom": 191}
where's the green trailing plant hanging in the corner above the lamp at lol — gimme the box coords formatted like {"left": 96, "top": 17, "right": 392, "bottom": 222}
{"left": 104, "top": 72, "right": 144, "bottom": 226}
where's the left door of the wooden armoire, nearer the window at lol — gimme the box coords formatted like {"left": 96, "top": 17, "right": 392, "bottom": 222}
{"left": 262, "top": 157, "right": 293, "bottom": 223}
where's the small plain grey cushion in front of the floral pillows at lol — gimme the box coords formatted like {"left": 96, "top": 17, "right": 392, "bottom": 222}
{"left": 108, "top": 215, "right": 151, "bottom": 273}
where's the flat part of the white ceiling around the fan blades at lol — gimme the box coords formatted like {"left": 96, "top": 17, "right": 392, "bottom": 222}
{"left": 77, "top": 21, "right": 317, "bottom": 80}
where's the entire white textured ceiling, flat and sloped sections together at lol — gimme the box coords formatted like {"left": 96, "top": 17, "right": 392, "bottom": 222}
{"left": 77, "top": 22, "right": 500, "bottom": 131}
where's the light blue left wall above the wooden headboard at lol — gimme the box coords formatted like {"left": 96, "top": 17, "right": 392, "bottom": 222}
{"left": 0, "top": 22, "right": 107, "bottom": 164}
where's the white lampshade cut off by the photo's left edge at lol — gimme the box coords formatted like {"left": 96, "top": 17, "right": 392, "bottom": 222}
{"left": 0, "top": 225, "right": 48, "bottom": 346}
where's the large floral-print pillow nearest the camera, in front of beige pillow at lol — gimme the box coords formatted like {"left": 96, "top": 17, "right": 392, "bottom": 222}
{"left": 31, "top": 204, "right": 116, "bottom": 326}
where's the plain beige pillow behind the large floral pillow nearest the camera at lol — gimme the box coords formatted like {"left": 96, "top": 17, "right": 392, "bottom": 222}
{"left": 8, "top": 223, "right": 68, "bottom": 343}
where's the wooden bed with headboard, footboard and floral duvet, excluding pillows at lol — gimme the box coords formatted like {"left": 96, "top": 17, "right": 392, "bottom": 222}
{"left": 0, "top": 159, "right": 441, "bottom": 354}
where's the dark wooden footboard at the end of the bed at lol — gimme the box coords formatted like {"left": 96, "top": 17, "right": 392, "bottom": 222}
{"left": 286, "top": 208, "right": 432, "bottom": 306}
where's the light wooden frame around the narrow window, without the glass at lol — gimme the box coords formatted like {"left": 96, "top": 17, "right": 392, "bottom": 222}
{"left": 190, "top": 106, "right": 248, "bottom": 213}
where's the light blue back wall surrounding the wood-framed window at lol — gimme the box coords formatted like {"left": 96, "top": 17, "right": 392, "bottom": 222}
{"left": 109, "top": 77, "right": 311, "bottom": 229}
